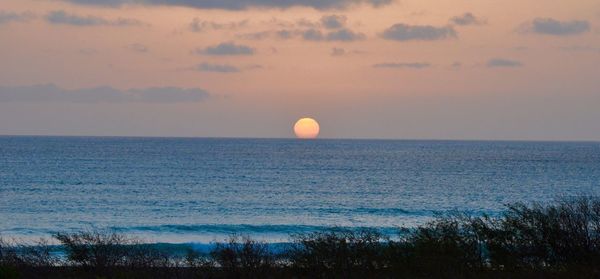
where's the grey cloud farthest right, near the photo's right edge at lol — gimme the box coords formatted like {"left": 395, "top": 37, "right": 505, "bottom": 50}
{"left": 524, "top": 18, "right": 590, "bottom": 36}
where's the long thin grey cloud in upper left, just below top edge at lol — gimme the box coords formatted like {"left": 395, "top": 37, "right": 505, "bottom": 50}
{"left": 46, "top": 11, "right": 142, "bottom": 26}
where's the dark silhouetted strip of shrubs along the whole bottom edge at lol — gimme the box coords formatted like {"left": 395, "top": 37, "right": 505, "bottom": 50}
{"left": 0, "top": 198, "right": 600, "bottom": 278}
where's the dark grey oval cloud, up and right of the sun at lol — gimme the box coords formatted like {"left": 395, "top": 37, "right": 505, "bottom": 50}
{"left": 381, "top": 23, "right": 456, "bottom": 41}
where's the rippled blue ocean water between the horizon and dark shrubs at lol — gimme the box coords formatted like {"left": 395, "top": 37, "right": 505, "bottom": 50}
{"left": 0, "top": 136, "right": 600, "bottom": 243}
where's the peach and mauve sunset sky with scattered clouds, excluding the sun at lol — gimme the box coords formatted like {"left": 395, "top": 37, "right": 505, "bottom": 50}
{"left": 0, "top": 0, "right": 600, "bottom": 141}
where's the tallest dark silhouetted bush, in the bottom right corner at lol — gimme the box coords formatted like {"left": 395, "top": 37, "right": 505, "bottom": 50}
{"left": 481, "top": 197, "right": 600, "bottom": 270}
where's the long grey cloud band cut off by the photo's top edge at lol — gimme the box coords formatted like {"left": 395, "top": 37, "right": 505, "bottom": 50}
{"left": 63, "top": 0, "right": 392, "bottom": 10}
